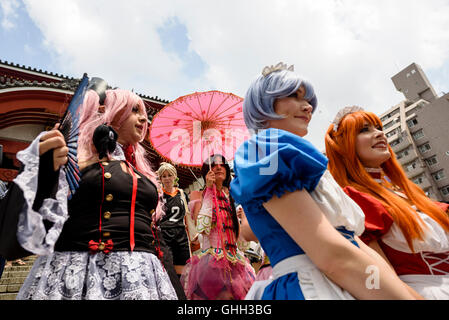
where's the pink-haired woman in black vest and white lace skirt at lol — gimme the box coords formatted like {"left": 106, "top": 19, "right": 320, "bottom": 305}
{"left": 10, "top": 89, "right": 185, "bottom": 300}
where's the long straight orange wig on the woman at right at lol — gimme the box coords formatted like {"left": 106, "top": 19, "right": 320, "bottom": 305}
{"left": 325, "top": 111, "right": 449, "bottom": 252}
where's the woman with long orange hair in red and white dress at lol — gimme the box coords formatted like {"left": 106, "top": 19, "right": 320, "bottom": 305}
{"left": 325, "top": 106, "right": 449, "bottom": 299}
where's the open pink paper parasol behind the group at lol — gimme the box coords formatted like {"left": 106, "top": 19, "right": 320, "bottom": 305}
{"left": 149, "top": 91, "right": 250, "bottom": 167}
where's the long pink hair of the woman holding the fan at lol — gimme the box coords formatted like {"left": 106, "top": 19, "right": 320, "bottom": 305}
{"left": 78, "top": 89, "right": 163, "bottom": 221}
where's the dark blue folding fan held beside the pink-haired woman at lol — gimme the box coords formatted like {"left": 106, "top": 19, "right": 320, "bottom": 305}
{"left": 59, "top": 73, "right": 89, "bottom": 199}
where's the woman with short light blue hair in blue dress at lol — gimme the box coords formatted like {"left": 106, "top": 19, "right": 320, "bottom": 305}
{"left": 230, "top": 64, "right": 418, "bottom": 300}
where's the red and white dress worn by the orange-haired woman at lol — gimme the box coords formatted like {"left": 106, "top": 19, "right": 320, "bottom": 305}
{"left": 344, "top": 171, "right": 449, "bottom": 300}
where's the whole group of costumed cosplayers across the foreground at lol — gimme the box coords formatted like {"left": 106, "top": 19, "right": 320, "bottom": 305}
{"left": 0, "top": 63, "right": 449, "bottom": 300}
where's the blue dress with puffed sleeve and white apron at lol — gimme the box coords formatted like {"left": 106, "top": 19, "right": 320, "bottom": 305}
{"left": 230, "top": 129, "right": 364, "bottom": 300}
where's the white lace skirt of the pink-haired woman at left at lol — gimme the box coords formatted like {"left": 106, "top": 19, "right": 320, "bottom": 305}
{"left": 17, "top": 251, "right": 177, "bottom": 300}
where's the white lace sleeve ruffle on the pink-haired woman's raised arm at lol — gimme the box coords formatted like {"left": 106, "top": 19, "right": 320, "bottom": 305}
{"left": 14, "top": 132, "right": 69, "bottom": 255}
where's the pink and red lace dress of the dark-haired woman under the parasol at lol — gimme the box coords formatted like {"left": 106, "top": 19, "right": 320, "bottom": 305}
{"left": 181, "top": 188, "right": 255, "bottom": 300}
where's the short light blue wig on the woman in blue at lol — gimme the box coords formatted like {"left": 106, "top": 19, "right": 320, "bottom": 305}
{"left": 243, "top": 70, "right": 318, "bottom": 131}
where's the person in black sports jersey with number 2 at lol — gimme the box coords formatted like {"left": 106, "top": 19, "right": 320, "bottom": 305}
{"left": 157, "top": 162, "right": 190, "bottom": 276}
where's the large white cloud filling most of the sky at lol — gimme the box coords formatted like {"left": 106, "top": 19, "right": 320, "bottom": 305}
{"left": 21, "top": 0, "right": 449, "bottom": 148}
